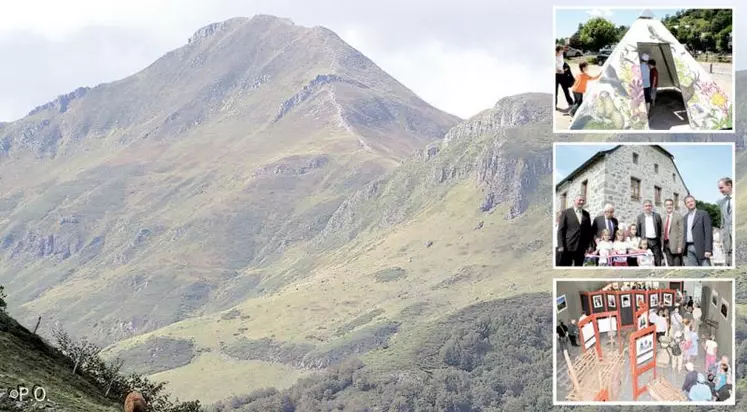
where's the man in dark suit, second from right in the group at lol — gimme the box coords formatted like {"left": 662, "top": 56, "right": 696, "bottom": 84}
{"left": 682, "top": 196, "right": 713, "bottom": 266}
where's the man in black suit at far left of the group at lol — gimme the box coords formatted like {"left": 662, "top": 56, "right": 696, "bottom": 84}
{"left": 558, "top": 195, "right": 594, "bottom": 266}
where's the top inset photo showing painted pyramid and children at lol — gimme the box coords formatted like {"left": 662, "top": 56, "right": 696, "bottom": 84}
{"left": 553, "top": 7, "right": 735, "bottom": 133}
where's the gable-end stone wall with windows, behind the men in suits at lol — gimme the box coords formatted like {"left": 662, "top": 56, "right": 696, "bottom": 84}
{"left": 605, "top": 145, "right": 688, "bottom": 229}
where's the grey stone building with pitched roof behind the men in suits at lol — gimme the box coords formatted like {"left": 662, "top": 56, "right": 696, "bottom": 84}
{"left": 555, "top": 145, "right": 689, "bottom": 226}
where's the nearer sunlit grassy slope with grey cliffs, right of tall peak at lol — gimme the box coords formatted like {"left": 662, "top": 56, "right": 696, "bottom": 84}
{"left": 98, "top": 95, "right": 572, "bottom": 402}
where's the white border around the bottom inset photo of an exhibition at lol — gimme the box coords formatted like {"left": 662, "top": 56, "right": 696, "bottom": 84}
{"left": 549, "top": 277, "right": 737, "bottom": 407}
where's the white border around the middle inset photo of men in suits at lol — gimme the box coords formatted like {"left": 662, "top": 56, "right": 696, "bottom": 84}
{"left": 550, "top": 141, "right": 739, "bottom": 270}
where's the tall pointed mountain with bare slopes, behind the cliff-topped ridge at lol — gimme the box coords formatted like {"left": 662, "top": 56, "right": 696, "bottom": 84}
{"left": 0, "top": 16, "right": 457, "bottom": 350}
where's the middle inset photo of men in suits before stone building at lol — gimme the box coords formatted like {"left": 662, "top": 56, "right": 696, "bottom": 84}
{"left": 553, "top": 143, "right": 736, "bottom": 269}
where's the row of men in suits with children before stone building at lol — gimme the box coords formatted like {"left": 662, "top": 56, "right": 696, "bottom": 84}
{"left": 556, "top": 177, "right": 734, "bottom": 266}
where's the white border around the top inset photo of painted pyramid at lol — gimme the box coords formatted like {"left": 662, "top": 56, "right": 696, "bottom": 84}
{"left": 547, "top": 4, "right": 737, "bottom": 134}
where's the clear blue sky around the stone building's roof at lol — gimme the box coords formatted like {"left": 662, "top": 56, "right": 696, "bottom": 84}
{"left": 554, "top": 144, "right": 734, "bottom": 203}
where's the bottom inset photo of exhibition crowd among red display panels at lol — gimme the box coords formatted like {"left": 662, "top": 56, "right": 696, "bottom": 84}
{"left": 553, "top": 278, "right": 736, "bottom": 406}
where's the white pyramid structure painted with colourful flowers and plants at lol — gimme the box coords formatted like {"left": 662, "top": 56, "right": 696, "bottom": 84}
{"left": 570, "top": 10, "right": 733, "bottom": 131}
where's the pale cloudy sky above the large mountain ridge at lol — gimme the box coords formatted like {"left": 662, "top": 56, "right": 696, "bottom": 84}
{"left": 0, "top": 0, "right": 747, "bottom": 121}
